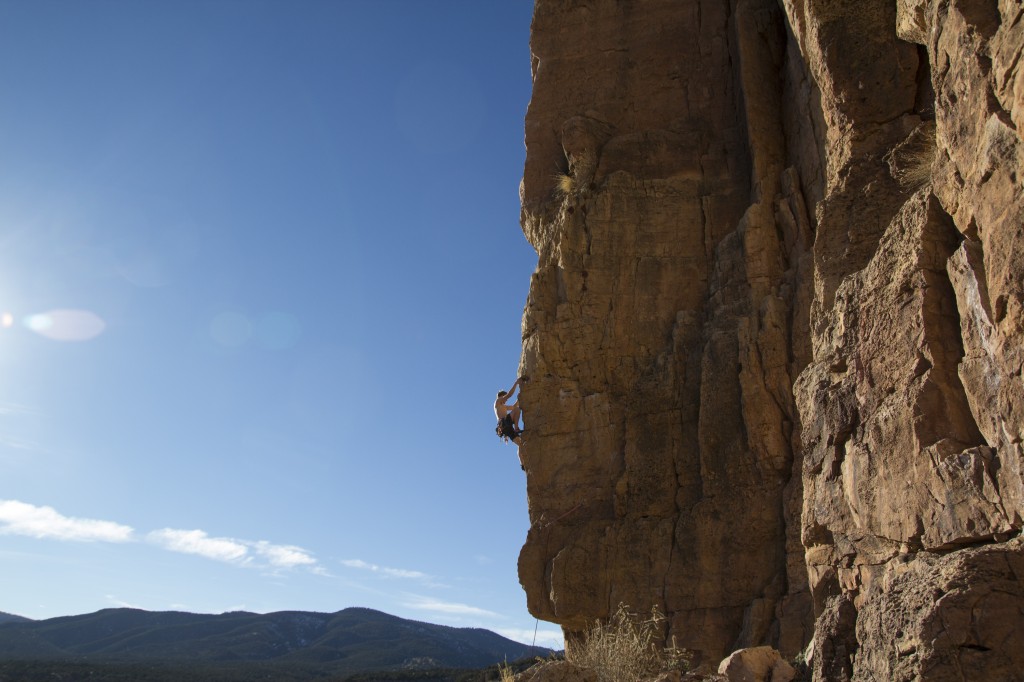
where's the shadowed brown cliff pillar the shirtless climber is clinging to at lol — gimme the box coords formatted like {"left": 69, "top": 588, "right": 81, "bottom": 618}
{"left": 519, "top": 0, "right": 812, "bottom": 659}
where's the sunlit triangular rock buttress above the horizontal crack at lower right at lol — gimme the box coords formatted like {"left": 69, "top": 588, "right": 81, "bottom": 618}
{"left": 796, "top": 190, "right": 1014, "bottom": 604}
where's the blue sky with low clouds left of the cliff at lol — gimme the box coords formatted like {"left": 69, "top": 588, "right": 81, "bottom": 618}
{"left": 0, "top": 0, "right": 558, "bottom": 644}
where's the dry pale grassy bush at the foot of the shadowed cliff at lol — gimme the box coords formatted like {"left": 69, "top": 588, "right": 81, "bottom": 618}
{"left": 565, "top": 604, "right": 691, "bottom": 682}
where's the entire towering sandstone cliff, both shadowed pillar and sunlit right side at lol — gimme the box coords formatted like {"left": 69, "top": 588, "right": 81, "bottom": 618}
{"left": 519, "top": 0, "right": 1024, "bottom": 680}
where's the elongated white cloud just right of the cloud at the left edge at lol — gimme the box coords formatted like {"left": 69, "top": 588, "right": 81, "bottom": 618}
{"left": 146, "top": 528, "right": 316, "bottom": 568}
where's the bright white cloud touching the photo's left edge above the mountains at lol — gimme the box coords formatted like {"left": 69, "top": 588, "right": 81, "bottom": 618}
{"left": 0, "top": 500, "right": 134, "bottom": 543}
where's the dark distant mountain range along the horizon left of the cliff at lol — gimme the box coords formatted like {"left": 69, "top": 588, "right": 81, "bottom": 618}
{"left": 0, "top": 608, "right": 551, "bottom": 679}
